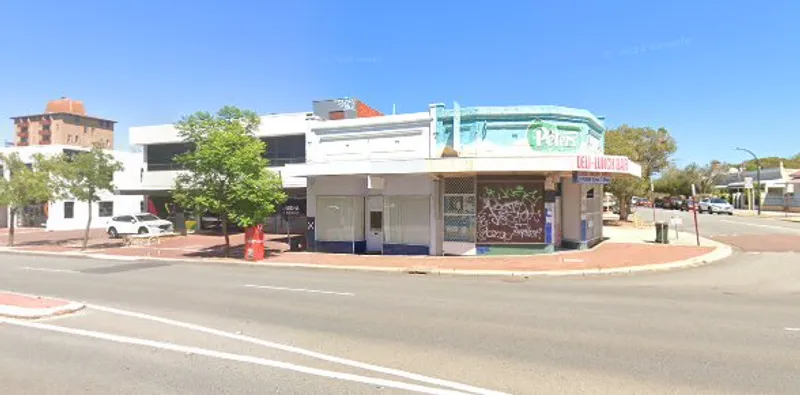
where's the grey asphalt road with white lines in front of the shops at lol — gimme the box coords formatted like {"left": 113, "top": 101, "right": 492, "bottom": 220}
{"left": 0, "top": 214, "right": 800, "bottom": 394}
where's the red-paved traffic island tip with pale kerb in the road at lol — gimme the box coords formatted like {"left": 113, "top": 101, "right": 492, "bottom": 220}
{"left": 0, "top": 291, "right": 84, "bottom": 319}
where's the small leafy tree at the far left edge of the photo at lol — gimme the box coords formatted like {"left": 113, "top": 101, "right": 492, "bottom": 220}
{"left": 0, "top": 153, "right": 56, "bottom": 246}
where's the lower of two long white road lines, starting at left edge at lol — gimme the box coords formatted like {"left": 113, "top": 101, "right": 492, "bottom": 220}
{"left": 0, "top": 318, "right": 476, "bottom": 395}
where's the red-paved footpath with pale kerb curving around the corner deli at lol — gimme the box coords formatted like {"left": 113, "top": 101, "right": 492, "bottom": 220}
{"left": 0, "top": 223, "right": 731, "bottom": 276}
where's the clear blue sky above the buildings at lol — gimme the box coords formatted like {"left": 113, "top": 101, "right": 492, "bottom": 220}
{"left": 0, "top": 0, "right": 800, "bottom": 164}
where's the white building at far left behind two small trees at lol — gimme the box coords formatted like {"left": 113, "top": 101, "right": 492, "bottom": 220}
{"left": 0, "top": 145, "right": 143, "bottom": 231}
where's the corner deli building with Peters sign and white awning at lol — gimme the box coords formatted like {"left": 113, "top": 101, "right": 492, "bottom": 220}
{"left": 283, "top": 104, "right": 641, "bottom": 255}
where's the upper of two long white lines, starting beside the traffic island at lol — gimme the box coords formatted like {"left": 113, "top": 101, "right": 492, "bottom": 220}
{"left": 86, "top": 303, "right": 502, "bottom": 395}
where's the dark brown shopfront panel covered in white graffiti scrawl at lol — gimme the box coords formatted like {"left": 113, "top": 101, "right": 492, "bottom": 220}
{"left": 477, "top": 182, "right": 545, "bottom": 243}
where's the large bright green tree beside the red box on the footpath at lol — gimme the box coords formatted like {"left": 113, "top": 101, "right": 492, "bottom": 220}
{"left": 172, "top": 106, "right": 287, "bottom": 257}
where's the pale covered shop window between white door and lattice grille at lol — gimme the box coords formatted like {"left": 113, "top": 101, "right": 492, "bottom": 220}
{"left": 383, "top": 196, "right": 431, "bottom": 245}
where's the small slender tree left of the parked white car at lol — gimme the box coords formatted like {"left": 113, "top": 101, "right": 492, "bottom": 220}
{"left": 53, "top": 145, "right": 123, "bottom": 249}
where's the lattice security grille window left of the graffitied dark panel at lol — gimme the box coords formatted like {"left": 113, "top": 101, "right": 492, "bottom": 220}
{"left": 442, "top": 177, "right": 476, "bottom": 243}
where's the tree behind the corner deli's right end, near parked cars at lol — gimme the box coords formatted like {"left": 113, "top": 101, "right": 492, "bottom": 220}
{"left": 605, "top": 125, "right": 677, "bottom": 221}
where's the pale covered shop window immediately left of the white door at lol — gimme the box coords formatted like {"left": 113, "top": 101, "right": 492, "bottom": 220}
{"left": 315, "top": 196, "right": 364, "bottom": 241}
